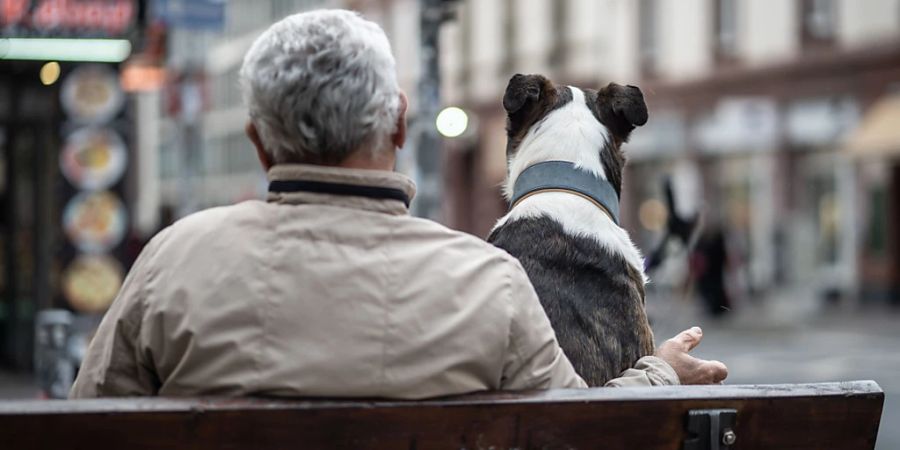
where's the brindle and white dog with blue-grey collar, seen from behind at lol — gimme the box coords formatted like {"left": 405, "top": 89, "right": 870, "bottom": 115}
{"left": 488, "top": 74, "right": 654, "bottom": 386}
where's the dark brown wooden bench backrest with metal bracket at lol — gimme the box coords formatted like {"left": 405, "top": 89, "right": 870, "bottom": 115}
{"left": 0, "top": 381, "right": 884, "bottom": 450}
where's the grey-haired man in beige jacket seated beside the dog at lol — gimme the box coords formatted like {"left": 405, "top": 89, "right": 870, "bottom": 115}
{"left": 71, "top": 11, "right": 725, "bottom": 398}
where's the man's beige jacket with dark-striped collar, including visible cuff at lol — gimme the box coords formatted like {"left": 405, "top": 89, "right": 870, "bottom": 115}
{"left": 70, "top": 166, "right": 678, "bottom": 398}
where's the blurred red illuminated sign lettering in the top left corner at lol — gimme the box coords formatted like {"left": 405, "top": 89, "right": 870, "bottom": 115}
{"left": 0, "top": 0, "right": 138, "bottom": 37}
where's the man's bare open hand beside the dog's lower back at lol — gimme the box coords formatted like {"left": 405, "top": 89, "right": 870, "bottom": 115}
{"left": 656, "top": 327, "right": 728, "bottom": 384}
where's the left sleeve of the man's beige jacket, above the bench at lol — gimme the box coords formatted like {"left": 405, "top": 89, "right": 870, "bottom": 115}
{"left": 69, "top": 246, "right": 159, "bottom": 399}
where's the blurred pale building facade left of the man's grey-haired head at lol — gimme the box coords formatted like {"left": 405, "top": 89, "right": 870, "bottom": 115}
{"left": 158, "top": 0, "right": 334, "bottom": 216}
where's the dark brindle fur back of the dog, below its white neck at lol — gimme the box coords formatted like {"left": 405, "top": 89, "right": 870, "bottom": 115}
{"left": 488, "top": 217, "right": 653, "bottom": 386}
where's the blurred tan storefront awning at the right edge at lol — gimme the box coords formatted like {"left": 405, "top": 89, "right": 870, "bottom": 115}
{"left": 846, "top": 94, "right": 900, "bottom": 158}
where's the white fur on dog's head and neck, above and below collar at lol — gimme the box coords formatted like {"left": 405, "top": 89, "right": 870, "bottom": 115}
{"left": 494, "top": 88, "right": 648, "bottom": 283}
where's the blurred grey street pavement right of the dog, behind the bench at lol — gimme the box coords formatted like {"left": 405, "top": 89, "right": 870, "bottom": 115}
{"left": 648, "top": 293, "right": 900, "bottom": 450}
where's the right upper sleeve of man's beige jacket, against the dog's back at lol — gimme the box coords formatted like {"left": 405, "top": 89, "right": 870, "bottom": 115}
{"left": 500, "top": 261, "right": 587, "bottom": 390}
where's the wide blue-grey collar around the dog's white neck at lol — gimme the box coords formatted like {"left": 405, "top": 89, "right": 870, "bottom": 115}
{"left": 509, "top": 161, "right": 619, "bottom": 225}
